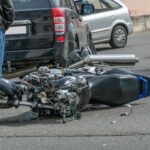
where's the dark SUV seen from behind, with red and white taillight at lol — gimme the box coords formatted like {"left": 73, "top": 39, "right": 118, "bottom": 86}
{"left": 5, "top": 0, "right": 93, "bottom": 68}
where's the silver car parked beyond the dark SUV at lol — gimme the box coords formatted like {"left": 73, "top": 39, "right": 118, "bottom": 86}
{"left": 74, "top": 0, "right": 133, "bottom": 48}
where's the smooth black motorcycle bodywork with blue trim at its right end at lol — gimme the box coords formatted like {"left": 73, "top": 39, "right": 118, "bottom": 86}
{"left": 88, "top": 69, "right": 150, "bottom": 106}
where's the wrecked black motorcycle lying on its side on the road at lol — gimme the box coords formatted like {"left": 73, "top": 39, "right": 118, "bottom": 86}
{"left": 0, "top": 55, "right": 150, "bottom": 122}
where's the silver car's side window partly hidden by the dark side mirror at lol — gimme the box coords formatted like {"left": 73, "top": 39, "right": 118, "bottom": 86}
{"left": 74, "top": 0, "right": 102, "bottom": 13}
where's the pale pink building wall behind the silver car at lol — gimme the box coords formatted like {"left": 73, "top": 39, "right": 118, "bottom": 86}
{"left": 122, "top": 0, "right": 150, "bottom": 16}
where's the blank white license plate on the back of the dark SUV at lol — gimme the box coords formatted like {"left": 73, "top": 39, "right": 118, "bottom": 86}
{"left": 6, "top": 26, "right": 27, "bottom": 35}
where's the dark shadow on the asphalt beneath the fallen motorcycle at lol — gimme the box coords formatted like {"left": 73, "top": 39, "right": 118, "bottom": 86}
{"left": 0, "top": 103, "right": 141, "bottom": 127}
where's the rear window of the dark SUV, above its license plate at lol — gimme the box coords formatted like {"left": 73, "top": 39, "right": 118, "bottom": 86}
{"left": 13, "top": 0, "right": 50, "bottom": 10}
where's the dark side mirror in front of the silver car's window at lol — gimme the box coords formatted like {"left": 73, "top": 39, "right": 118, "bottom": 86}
{"left": 81, "top": 4, "right": 95, "bottom": 15}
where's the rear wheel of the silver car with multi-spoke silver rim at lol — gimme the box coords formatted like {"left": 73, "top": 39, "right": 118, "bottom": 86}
{"left": 110, "top": 26, "right": 128, "bottom": 48}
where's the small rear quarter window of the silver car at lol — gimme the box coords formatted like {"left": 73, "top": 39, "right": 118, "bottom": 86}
{"left": 101, "top": 0, "right": 121, "bottom": 11}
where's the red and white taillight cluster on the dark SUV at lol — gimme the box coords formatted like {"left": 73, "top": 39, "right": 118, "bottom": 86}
{"left": 52, "top": 8, "right": 65, "bottom": 32}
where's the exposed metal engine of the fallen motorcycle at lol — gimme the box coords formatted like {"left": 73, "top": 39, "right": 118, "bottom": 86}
{"left": 24, "top": 67, "right": 90, "bottom": 118}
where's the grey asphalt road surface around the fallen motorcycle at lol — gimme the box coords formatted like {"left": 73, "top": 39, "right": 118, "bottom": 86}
{"left": 0, "top": 32, "right": 150, "bottom": 150}
